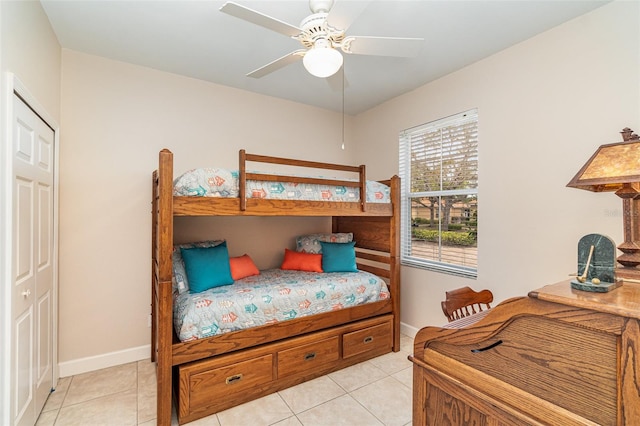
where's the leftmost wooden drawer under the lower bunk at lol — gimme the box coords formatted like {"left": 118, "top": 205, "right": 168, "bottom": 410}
{"left": 179, "top": 354, "right": 274, "bottom": 415}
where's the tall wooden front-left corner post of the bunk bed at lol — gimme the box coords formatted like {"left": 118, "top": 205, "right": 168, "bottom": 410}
{"left": 152, "top": 149, "right": 173, "bottom": 426}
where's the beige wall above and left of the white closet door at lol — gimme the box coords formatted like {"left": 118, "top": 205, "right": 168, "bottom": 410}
{"left": 0, "top": 1, "right": 61, "bottom": 424}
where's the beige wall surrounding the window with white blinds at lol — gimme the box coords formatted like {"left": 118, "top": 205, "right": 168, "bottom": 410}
{"left": 354, "top": 2, "right": 640, "bottom": 329}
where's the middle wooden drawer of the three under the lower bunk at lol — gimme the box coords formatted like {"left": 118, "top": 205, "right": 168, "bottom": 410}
{"left": 278, "top": 336, "right": 340, "bottom": 377}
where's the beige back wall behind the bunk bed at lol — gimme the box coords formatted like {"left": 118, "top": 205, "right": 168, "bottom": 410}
{"left": 60, "top": 50, "right": 352, "bottom": 368}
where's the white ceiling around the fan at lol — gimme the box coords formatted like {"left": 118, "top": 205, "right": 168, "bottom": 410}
{"left": 41, "top": 0, "right": 609, "bottom": 115}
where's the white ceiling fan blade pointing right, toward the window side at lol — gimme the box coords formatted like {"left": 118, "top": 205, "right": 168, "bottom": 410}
{"left": 342, "top": 36, "right": 424, "bottom": 58}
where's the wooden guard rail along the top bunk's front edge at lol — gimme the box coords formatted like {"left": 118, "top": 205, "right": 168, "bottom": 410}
{"left": 238, "top": 149, "right": 367, "bottom": 212}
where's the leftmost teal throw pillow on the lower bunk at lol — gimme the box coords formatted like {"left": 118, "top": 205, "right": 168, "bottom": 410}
{"left": 180, "top": 242, "right": 233, "bottom": 293}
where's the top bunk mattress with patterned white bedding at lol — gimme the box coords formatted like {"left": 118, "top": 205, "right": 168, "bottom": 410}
{"left": 173, "top": 168, "right": 391, "bottom": 203}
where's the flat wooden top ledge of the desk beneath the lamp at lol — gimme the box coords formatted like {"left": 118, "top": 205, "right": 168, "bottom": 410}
{"left": 529, "top": 280, "right": 640, "bottom": 319}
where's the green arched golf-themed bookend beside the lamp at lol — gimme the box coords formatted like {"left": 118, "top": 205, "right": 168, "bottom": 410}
{"left": 571, "top": 234, "right": 622, "bottom": 293}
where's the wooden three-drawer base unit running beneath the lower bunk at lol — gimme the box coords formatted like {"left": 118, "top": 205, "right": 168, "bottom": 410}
{"left": 177, "top": 315, "right": 393, "bottom": 424}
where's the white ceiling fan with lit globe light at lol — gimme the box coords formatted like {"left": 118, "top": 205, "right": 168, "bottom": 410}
{"left": 220, "top": 0, "right": 424, "bottom": 78}
